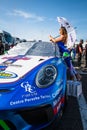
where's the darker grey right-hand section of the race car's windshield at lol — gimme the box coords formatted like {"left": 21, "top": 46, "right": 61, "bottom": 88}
{"left": 26, "top": 42, "right": 59, "bottom": 56}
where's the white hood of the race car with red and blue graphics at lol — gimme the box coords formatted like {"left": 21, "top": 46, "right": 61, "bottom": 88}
{"left": 0, "top": 55, "right": 48, "bottom": 84}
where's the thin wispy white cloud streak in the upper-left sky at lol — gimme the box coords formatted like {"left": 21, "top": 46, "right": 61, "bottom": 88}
{"left": 9, "top": 10, "right": 45, "bottom": 21}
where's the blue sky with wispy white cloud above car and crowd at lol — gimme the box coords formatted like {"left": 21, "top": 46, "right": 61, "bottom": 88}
{"left": 0, "top": 0, "right": 87, "bottom": 41}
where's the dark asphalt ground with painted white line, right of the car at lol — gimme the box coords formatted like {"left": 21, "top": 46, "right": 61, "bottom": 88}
{"left": 47, "top": 58, "right": 87, "bottom": 130}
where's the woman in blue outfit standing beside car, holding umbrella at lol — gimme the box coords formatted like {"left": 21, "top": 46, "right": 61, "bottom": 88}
{"left": 49, "top": 27, "right": 81, "bottom": 80}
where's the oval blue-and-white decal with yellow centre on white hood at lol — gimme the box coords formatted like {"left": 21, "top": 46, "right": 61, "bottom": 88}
{"left": 0, "top": 71, "right": 17, "bottom": 79}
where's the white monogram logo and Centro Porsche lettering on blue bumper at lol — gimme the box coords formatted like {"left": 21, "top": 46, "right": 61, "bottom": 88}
{"left": 10, "top": 81, "right": 51, "bottom": 106}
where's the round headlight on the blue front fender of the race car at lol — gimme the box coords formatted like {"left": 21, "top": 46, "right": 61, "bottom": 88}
{"left": 36, "top": 65, "right": 57, "bottom": 88}
